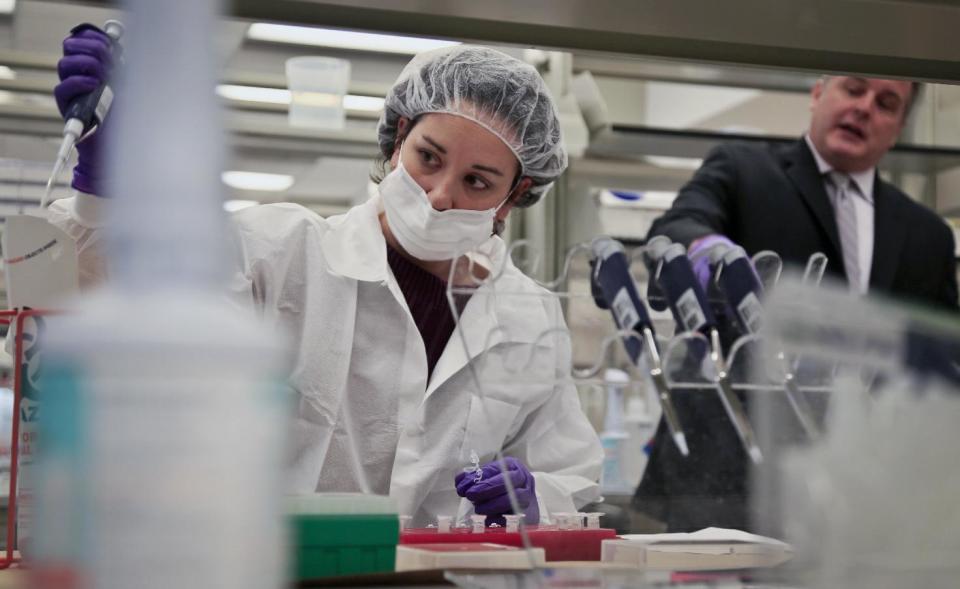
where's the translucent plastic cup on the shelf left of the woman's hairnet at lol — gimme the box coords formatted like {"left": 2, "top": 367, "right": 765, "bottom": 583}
{"left": 286, "top": 55, "right": 350, "bottom": 129}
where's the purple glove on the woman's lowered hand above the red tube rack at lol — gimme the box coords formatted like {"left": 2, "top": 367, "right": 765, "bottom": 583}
{"left": 456, "top": 456, "right": 540, "bottom": 526}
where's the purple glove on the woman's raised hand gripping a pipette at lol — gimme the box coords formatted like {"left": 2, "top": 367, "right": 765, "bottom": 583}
{"left": 53, "top": 29, "right": 113, "bottom": 196}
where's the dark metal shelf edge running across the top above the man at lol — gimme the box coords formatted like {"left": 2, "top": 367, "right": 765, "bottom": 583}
{"left": 233, "top": 0, "right": 960, "bottom": 82}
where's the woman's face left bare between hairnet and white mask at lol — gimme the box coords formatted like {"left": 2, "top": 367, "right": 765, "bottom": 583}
{"left": 390, "top": 113, "right": 529, "bottom": 220}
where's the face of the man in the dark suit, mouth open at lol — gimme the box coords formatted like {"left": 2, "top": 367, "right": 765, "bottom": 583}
{"left": 810, "top": 76, "right": 912, "bottom": 173}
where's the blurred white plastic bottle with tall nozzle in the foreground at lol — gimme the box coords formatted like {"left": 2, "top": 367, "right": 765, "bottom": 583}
{"left": 32, "top": 0, "right": 286, "bottom": 589}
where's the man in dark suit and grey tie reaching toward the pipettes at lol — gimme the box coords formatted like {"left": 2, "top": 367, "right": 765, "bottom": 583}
{"left": 634, "top": 77, "right": 958, "bottom": 531}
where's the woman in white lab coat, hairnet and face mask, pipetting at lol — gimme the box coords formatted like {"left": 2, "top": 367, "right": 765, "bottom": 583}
{"left": 51, "top": 31, "right": 602, "bottom": 525}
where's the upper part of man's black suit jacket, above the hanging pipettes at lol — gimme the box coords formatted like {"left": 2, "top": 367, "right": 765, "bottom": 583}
{"left": 650, "top": 139, "right": 958, "bottom": 309}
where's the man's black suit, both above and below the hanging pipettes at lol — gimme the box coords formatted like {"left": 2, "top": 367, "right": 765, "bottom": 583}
{"left": 634, "top": 140, "right": 957, "bottom": 535}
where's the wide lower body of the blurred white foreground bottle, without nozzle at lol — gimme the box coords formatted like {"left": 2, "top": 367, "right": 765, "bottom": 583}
{"left": 34, "top": 290, "right": 289, "bottom": 589}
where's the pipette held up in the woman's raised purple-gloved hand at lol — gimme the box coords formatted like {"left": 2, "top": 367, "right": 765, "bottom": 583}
{"left": 40, "top": 20, "right": 123, "bottom": 209}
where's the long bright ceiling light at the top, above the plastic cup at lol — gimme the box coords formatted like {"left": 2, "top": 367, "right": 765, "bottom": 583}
{"left": 247, "top": 23, "right": 460, "bottom": 55}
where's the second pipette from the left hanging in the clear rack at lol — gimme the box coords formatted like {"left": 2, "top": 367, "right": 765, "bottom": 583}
{"left": 644, "top": 236, "right": 763, "bottom": 463}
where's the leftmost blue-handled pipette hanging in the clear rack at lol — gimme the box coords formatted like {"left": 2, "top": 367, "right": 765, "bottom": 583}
{"left": 590, "top": 237, "right": 690, "bottom": 456}
